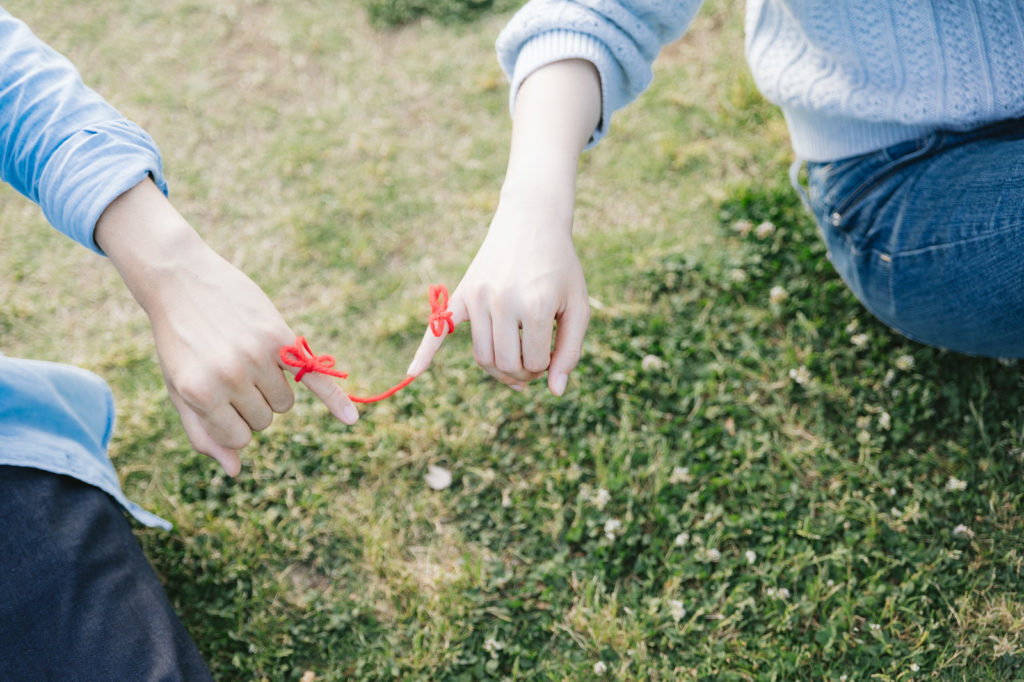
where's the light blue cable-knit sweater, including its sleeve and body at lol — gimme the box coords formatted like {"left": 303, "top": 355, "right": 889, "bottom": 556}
{"left": 497, "top": 0, "right": 1024, "bottom": 161}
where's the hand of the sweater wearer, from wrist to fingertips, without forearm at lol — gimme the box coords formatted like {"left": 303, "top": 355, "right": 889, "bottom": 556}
{"left": 409, "top": 188, "right": 590, "bottom": 395}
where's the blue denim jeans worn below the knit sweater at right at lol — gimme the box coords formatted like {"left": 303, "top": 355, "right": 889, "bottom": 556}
{"left": 807, "top": 119, "right": 1024, "bottom": 357}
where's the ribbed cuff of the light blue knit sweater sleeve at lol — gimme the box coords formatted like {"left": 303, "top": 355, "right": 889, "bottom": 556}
{"left": 509, "top": 30, "right": 623, "bottom": 148}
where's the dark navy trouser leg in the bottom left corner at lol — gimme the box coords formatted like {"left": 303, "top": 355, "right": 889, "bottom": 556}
{"left": 0, "top": 466, "right": 212, "bottom": 681}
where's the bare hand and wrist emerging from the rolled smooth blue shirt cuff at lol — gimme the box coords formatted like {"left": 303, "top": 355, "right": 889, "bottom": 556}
{"left": 94, "top": 180, "right": 358, "bottom": 476}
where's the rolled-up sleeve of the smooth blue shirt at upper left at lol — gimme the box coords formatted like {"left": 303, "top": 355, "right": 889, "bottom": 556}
{"left": 0, "top": 9, "right": 167, "bottom": 253}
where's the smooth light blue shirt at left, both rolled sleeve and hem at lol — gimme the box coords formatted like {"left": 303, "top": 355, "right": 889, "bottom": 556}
{"left": 0, "top": 9, "right": 170, "bottom": 528}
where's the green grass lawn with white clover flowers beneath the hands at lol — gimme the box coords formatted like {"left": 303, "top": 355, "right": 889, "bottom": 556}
{"left": 0, "top": 0, "right": 1024, "bottom": 680}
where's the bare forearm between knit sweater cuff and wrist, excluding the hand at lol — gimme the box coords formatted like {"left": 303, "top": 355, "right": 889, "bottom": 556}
{"left": 502, "top": 59, "right": 601, "bottom": 219}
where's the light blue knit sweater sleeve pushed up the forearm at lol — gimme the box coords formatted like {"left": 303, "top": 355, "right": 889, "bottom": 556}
{"left": 496, "top": 0, "right": 702, "bottom": 147}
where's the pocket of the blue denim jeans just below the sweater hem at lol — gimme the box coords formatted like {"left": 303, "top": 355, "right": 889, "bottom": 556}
{"left": 812, "top": 134, "right": 939, "bottom": 231}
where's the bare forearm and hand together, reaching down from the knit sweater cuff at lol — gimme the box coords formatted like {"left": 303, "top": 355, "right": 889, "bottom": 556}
{"left": 409, "top": 59, "right": 601, "bottom": 395}
